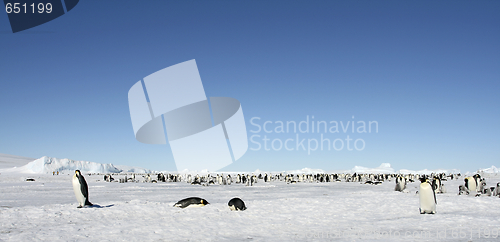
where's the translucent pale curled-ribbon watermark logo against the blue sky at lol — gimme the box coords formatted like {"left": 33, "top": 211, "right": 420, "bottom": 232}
{"left": 128, "top": 60, "right": 248, "bottom": 171}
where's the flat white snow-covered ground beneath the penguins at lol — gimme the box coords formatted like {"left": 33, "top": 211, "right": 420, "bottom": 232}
{"left": 0, "top": 154, "right": 500, "bottom": 241}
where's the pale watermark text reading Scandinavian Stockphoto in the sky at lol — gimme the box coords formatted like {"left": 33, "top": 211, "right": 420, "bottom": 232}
{"left": 250, "top": 115, "right": 378, "bottom": 155}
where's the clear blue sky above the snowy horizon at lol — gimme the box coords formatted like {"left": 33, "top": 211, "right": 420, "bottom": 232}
{"left": 0, "top": 0, "right": 500, "bottom": 172}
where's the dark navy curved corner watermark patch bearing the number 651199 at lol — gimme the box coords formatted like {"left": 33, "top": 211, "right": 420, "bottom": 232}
{"left": 3, "top": 0, "right": 79, "bottom": 33}
